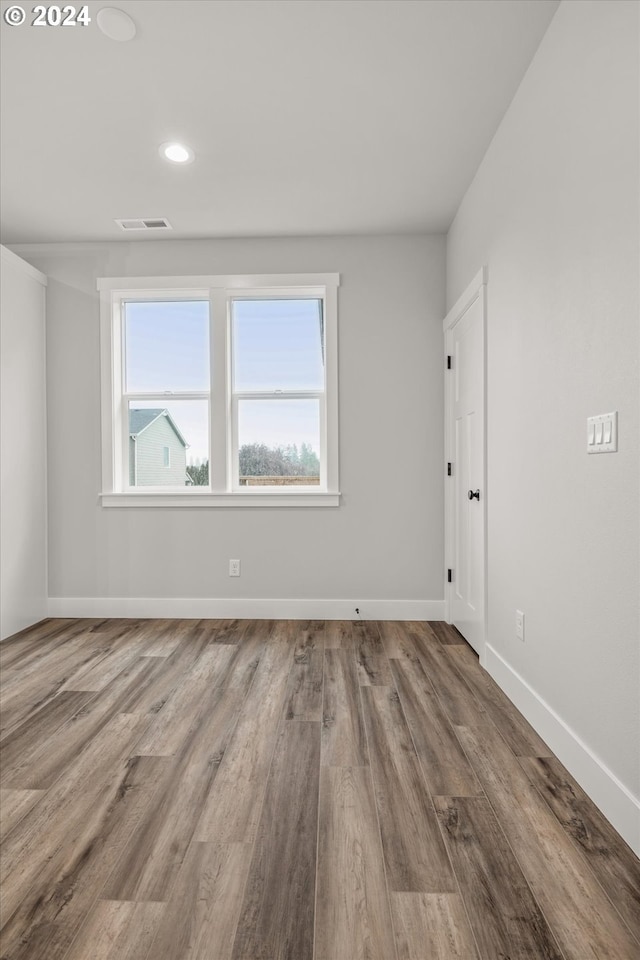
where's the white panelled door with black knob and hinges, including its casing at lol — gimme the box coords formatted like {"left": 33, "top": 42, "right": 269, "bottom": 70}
{"left": 445, "top": 274, "right": 486, "bottom": 657}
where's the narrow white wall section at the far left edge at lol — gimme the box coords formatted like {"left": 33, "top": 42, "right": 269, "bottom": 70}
{"left": 0, "top": 247, "right": 47, "bottom": 639}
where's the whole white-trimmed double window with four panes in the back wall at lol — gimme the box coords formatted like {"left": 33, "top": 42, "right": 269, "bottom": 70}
{"left": 98, "top": 274, "right": 339, "bottom": 506}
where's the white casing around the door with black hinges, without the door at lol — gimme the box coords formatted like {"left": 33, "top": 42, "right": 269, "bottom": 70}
{"left": 442, "top": 267, "right": 488, "bottom": 666}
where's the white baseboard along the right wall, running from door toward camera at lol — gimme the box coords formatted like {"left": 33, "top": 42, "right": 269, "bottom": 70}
{"left": 485, "top": 644, "right": 640, "bottom": 856}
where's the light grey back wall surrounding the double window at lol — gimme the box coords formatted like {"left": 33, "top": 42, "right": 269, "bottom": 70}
{"left": 11, "top": 237, "right": 444, "bottom": 617}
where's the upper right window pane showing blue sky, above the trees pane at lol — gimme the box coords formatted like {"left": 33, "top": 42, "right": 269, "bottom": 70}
{"left": 233, "top": 300, "right": 324, "bottom": 392}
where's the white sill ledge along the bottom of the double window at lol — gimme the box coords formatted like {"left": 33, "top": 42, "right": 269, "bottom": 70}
{"left": 100, "top": 490, "right": 340, "bottom": 507}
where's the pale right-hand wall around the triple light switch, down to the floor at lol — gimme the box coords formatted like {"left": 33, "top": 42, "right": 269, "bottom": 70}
{"left": 447, "top": 0, "right": 640, "bottom": 852}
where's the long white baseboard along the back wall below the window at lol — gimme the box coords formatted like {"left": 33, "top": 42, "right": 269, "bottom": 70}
{"left": 49, "top": 597, "right": 445, "bottom": 620}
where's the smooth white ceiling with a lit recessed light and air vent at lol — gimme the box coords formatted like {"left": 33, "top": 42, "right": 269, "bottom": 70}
{"left": 0, "top": 0, "right": 558, "bottom": 243}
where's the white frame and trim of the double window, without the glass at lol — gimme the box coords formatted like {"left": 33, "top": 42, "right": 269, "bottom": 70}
{"left": 98, "top": 273, "right": 340, "bottom": 507}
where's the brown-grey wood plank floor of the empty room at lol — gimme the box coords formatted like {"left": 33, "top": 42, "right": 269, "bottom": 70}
{"left": 0, "top": 620, "right": 640, "bottom": 960}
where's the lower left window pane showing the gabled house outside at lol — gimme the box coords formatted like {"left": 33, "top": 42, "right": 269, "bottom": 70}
{"left": 129, "top": 400, "right": 209, "bottom": 487}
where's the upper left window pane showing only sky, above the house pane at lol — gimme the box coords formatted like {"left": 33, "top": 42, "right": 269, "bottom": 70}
{"left": 124, "top": 300, "right": 209, "bottom": 393}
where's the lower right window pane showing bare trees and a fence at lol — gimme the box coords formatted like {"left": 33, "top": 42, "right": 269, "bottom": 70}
{"left": 238, "top": 400, "right": 320, "bottom": 486}
